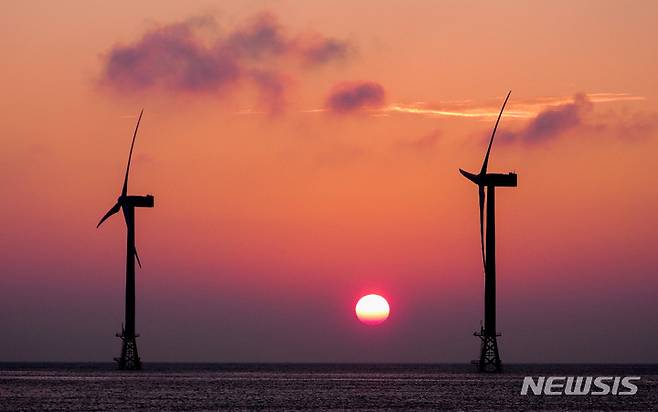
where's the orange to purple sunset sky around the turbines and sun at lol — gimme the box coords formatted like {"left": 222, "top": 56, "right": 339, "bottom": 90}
{"left": 0, "top": 1, "right": 658, "bottom": 363}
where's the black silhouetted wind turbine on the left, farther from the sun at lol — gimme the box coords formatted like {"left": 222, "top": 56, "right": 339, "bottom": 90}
{"left": 96, "top": 109, "right": 153, "bottom": 370}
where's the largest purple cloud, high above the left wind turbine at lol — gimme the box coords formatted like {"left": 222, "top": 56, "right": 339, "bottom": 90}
{"left": 100, "top": 13, "right": 351, "bottom": 112}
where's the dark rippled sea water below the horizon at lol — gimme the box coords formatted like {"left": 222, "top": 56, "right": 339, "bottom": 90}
{"left": 0, "top": 363, "right": 658, "bottom": 411}
